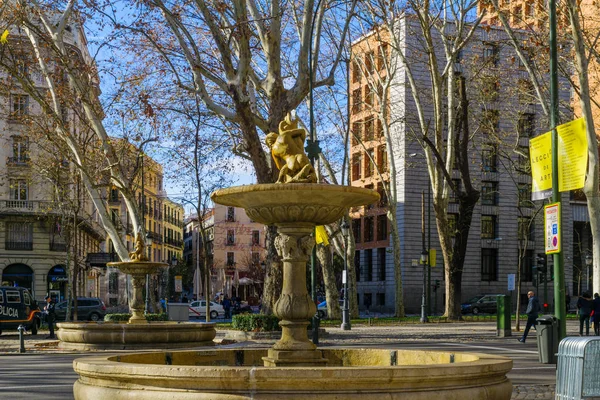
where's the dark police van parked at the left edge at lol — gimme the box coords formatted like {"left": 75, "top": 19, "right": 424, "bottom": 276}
{"left": 0, "top": 286, "right": 41, "bottom": 335}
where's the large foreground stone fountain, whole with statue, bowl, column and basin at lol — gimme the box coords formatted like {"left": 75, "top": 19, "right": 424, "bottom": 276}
{"left": 69, "top": 117, "right": 512, "bottom": 400}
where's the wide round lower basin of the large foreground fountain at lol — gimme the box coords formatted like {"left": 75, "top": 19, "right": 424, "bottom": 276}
{"left": 73, "top": 348, "right": 512, "bottom": 400}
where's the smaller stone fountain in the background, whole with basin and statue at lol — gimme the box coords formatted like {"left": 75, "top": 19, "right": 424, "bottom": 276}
{"left": 57, "top": 232, "right": 216, "bottom": 350}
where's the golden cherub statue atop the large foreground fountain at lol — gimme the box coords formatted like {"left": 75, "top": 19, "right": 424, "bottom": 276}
{"left": 265, "top": 114, "right": 317, "bottom": 183}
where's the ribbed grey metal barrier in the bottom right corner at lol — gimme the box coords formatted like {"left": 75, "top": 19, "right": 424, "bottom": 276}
{"left": 555, "top": 337, "right": 600, "bottom": 400}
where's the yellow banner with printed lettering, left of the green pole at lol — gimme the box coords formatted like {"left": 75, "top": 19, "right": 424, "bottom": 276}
{"left": 529, "top": 132, "right": 552, "bottom": 194}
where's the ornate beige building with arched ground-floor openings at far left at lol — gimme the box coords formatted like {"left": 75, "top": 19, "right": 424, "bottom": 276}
{"left": 0, "top": 20, "right": 105, "bottom": 300}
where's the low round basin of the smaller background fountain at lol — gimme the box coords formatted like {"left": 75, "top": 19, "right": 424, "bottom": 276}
{"left": 57, "top": 321, "right": 217, "bottom": 350}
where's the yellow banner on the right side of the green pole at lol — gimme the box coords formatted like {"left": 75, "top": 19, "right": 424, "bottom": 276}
{"left": 556, "top": 118, "right": 588, "bottom": 192}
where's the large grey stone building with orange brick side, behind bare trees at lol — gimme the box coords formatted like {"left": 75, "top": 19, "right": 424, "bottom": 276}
{"left": 349, "top": 18, "right": 573, "bottom": 313}
